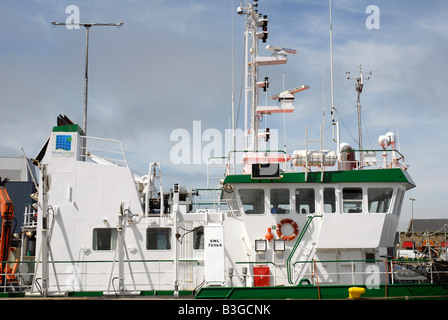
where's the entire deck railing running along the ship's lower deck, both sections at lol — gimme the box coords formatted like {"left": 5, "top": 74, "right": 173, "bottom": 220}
{"left": 0, "top": 257, "right": 440, "bottom": 295}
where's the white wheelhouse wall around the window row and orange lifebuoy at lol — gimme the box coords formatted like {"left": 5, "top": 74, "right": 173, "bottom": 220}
{"left": 225, "top": 183, "right": 408, "bottom": 285}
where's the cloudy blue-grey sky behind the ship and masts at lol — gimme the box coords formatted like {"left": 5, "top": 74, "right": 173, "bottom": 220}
{"left": 0, "top": 0, "right": 448, "bottom": 230}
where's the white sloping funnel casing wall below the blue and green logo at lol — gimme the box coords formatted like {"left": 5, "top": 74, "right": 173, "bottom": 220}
{"left": 36, "top": 134, "right": 147, "bottom": 292}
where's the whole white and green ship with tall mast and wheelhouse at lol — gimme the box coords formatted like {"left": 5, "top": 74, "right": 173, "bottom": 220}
{"left": 8, "top": 1, "right": 446, "bottom": 298}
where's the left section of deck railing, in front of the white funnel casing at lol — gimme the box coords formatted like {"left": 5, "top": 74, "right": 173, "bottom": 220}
{"left": 22, "top": 259, "right": 202, "bottom": 295}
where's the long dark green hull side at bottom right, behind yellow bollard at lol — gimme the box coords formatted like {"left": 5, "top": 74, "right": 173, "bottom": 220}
{"left": 195, "top": 283, "right": 448, "bottom": 300}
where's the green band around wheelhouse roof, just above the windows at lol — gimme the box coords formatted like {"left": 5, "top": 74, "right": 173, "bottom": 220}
{"left": 224, "top": 168, "right": 415, "bottom": 189}
